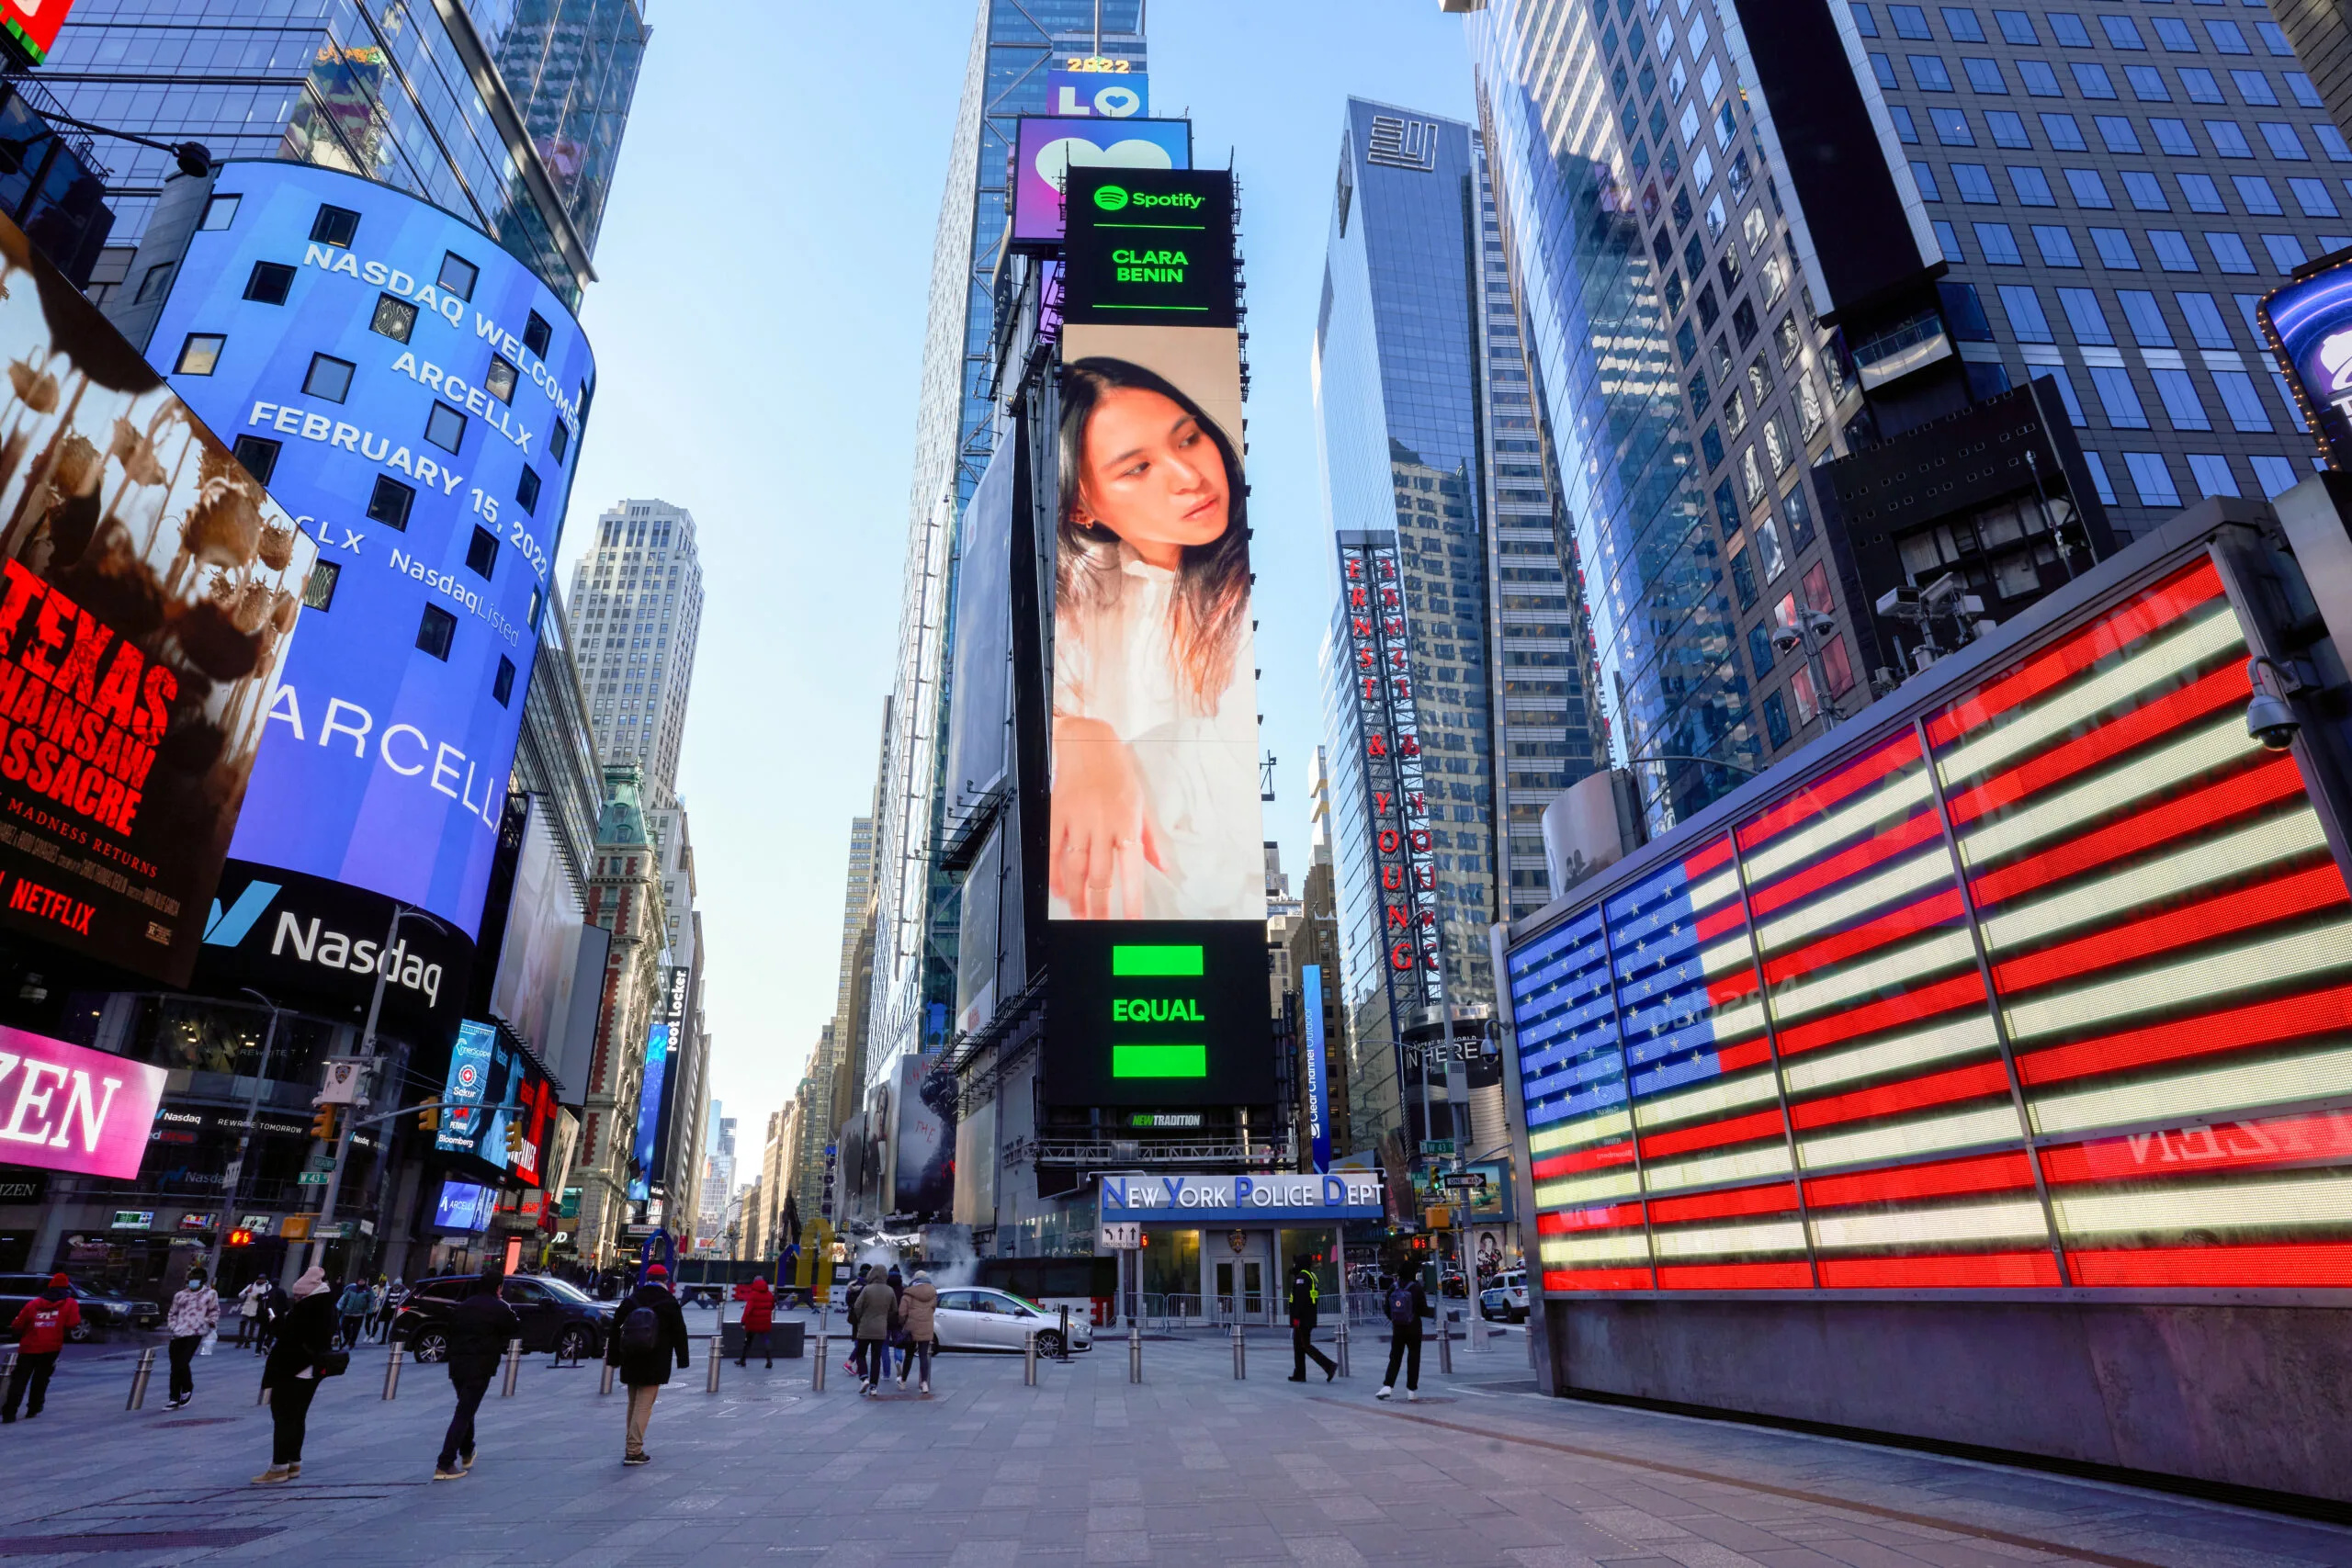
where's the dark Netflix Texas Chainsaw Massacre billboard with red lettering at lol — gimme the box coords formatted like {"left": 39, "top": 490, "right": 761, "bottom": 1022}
{"left": 0, "top": 199, "right": 318, "bottom": 985}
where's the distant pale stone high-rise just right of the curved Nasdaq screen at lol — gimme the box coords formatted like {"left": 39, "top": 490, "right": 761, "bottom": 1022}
{"left": 567, "top": 501, "right": 703, "bottom": 808}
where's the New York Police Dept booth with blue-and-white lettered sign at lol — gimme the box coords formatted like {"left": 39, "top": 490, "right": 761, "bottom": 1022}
{"left": 1101, "top": 1170, "right": 1381, "bottom": 1324}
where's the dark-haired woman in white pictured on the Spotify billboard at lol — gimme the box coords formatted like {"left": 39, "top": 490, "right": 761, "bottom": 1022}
{"left": 1049, "top": 355, "right": 1265, "bottom": 919}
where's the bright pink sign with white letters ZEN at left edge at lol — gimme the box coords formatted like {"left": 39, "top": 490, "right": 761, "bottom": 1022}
{"left": 0, "top": 1027, "right": 164, "bottom": 1180}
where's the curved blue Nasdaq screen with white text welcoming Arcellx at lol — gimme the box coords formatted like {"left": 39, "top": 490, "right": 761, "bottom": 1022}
{"left": 148, "top": 163, "right": 595, "bottom": 936}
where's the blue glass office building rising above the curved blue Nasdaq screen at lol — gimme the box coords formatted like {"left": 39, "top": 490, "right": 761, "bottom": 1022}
{"left": 42, "top": 0, "right": 650, "bottom": 306}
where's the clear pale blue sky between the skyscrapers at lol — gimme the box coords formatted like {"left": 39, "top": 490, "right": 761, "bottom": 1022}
{"left": 562, "top": 0, "right": 1470, "bottom": 1128}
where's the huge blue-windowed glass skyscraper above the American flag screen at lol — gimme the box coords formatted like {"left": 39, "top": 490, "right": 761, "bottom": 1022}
{"left": 1449, "top": 0, "right": 2352, "bottom": 825}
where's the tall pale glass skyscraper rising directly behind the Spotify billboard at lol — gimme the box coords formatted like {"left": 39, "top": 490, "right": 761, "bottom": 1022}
{"left": 865, "top": 0, "right": 1146, "bottom": 1100}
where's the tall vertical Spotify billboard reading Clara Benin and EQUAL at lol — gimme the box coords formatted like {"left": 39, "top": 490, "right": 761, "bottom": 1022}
{"left": 1046, "top": 169, "right": 1275, "bottom": 1105}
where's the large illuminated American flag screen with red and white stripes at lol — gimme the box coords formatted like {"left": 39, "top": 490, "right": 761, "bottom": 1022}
{"left": 1508, "top": 559, "right": 2352, "bottom": 1293}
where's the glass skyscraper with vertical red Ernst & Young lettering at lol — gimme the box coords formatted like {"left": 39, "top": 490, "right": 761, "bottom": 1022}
{"left": 1315, "top": 98, "right": 1592, "bottom": 1166}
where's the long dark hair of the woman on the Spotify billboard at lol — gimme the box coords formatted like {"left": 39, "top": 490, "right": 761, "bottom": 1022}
{"left": 1054, "top": 360, "right": 1249, "bottom": 715}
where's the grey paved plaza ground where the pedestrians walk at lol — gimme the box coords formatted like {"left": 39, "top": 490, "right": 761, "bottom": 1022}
{"left": 0, "top": 1337, "right": 2352, "bottom": 1568}
